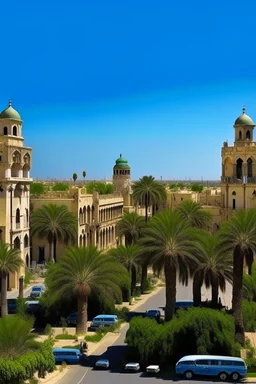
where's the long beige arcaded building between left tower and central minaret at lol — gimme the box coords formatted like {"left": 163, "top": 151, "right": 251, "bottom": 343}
{"left": 31, "top": 188, "right": 123, "bottom": 262}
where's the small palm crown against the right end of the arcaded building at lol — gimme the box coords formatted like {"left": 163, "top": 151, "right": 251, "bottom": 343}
{"left": 117, "top": 212, "right": 146, "bottom": 245}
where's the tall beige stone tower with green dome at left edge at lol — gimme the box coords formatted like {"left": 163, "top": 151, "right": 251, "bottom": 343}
{"left": 0, "top": 101, "right": 32, "bottom": 289}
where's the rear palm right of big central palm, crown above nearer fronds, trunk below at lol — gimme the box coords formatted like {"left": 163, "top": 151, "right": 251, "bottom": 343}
{"left": 176, "top": 200, "right": 212, "bottom": 306}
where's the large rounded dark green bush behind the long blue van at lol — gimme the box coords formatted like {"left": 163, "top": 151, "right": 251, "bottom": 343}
{"left": 126, "top": 308, "right": 239, "bottom": 366}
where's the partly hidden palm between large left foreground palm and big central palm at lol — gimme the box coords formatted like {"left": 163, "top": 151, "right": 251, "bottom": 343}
{"left": 109, "top": 245, "right": 141, "bottom": 296}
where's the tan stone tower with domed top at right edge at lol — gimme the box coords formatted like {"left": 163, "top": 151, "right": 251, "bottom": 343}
{"left": 221, "top": 108, "right": 256, "bottom": 219}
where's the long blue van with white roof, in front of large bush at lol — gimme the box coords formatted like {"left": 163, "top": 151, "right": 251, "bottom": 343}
{"left": 176, "top": 355, "right": 247, "bottom": 381}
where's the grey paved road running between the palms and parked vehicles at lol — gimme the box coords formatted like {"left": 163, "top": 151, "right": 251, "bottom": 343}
{"left": 58, "top": 285, "right": 230, "bottom": 384}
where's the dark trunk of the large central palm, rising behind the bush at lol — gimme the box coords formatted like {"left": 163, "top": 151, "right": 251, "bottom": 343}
{"left": 164, "top": 260, "right": 176, "bottom": 321}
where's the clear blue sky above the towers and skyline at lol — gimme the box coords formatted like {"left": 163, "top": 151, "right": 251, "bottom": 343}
{"left": 0, "top": 0, "right": 256, "bottom": 180}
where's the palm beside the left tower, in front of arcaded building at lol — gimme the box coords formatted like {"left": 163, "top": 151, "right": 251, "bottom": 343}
{"left": 31, "top": 204, "right": 77, "bottom": 261}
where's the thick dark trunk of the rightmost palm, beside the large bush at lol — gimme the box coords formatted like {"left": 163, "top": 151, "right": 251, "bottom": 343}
{"left": 232, "top": 247, "right": 245, "bottom": 346}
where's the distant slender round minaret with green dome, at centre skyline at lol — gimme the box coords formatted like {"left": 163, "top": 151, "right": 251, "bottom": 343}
{"left": 113, "top": 154, "right": 131, "bottom": 210}
